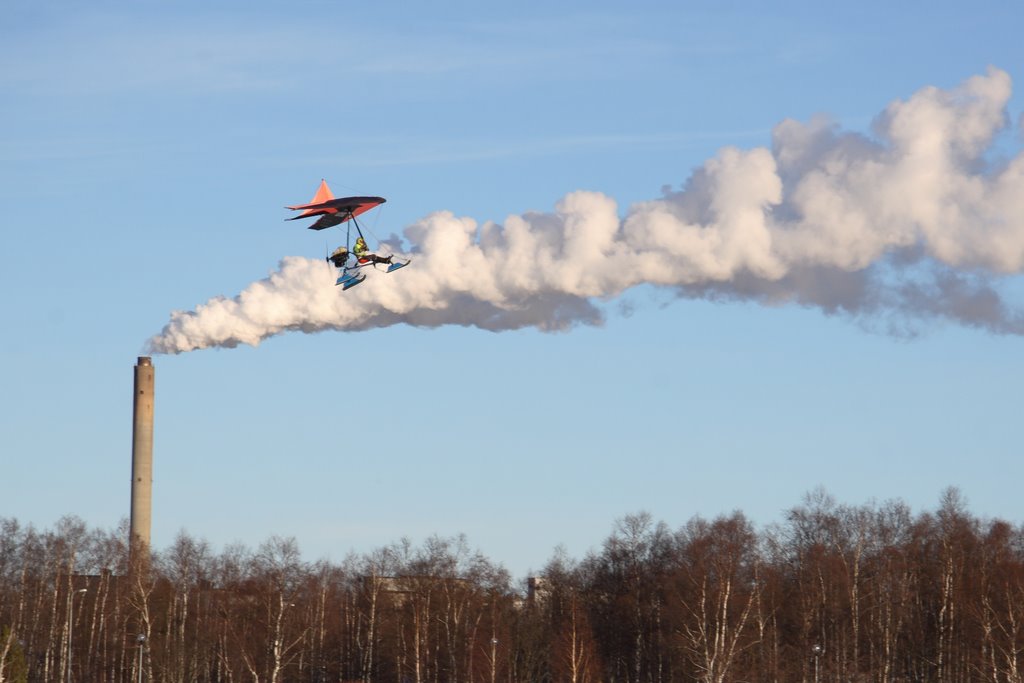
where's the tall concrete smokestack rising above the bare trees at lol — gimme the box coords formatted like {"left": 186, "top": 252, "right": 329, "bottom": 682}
{"left": 129, "top": 355, "right": 155, "bottom": 558}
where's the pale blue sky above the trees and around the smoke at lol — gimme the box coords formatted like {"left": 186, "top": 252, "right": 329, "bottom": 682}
{"left": 0, "top": 2, "right": 1024, "bottom": 577}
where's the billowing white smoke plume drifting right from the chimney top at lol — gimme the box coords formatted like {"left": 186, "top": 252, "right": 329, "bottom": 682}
{"left": 147, "top": 68, "right": 1024, "bottom": 353}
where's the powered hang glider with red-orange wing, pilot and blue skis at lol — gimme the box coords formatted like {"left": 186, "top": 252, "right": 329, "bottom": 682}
{"left": 286, "top": 180, "right": 412, "bottom": 290}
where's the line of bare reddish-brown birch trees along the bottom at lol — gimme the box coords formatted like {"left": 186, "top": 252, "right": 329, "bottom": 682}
{"left": 0, "top": 489, "right": 1024, "bottom": 683}
